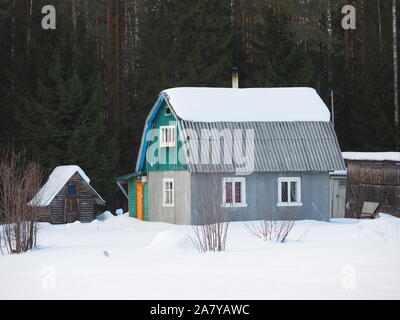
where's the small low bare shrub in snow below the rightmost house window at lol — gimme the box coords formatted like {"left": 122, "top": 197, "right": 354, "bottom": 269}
{"left": 245, "top": 212, "right": 297, "bottom": 243}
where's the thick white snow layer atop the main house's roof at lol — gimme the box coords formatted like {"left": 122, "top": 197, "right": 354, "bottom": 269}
{"left": 162, "top": 88, "right": 330, "bottom": 122}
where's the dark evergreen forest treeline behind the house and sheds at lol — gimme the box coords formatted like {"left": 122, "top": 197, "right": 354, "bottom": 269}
{"left": 0, "top": 0, "right": 400, "bottom": 207}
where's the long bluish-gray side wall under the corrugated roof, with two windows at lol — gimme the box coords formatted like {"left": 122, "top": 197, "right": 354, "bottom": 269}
{"left": 191, "top": 172, "right": 330, "bottom": 224}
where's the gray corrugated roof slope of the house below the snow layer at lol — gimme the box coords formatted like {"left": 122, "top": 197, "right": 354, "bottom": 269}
{"left": 178, "top": 120, "right": 346, "bottom": 172}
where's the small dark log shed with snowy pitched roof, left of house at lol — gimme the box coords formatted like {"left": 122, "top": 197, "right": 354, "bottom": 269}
{"left": 29, "top": 165, "right": 105, "bottom": 224}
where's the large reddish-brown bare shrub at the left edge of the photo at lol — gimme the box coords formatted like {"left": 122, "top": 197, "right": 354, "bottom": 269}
{"left": 0, "top": 152, "right": 42, "bottom": 254}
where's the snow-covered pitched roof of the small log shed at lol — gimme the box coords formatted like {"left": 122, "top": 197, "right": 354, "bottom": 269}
{"left": 29, "top": 165, "right": 104, "bottom": 207}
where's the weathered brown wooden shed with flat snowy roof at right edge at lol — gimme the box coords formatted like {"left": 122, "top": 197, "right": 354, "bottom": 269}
{"left": 343, "top": 152, "right": 400, "bottom": 218}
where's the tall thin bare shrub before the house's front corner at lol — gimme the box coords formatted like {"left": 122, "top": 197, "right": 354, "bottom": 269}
{"left": 193, "top": 174, "right": 231, "bottom": 252}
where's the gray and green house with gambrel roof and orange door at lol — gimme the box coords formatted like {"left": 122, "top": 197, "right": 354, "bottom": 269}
{"left": 117, "top": 88, "right": 346, "bottom": 224}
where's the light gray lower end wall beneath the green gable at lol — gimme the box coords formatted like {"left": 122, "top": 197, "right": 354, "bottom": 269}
{"left": 148, "top": 171, "right": 191, "bottom": 224}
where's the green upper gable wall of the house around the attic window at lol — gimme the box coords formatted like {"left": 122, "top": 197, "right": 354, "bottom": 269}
{"left": 146, "top": 102, "right": 187, "bottom": 171}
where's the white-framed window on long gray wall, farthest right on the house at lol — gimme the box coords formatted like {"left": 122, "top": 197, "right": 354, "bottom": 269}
{"left": 278, "top": 177, "right": 303, "bottom": 206}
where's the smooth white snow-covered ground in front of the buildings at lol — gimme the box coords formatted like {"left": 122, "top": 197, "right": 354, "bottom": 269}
{"left": 0, "top": 215, "right": 400, "bottom": 299}
